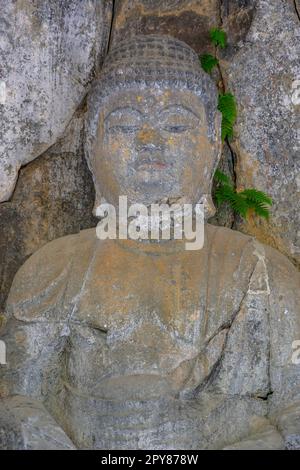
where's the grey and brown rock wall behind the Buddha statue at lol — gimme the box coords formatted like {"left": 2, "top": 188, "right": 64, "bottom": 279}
{"left": 0, "top": 0, "right": 300, "bottom": 309}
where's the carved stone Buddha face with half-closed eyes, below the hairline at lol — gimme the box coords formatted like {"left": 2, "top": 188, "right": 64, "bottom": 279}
{"left": 94, "top": 87, "right": 219, "bottom": 206}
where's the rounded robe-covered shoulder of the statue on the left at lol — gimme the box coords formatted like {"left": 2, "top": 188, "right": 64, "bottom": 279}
{"left": 7, "top": 228, "right": 97, "bottom": 318}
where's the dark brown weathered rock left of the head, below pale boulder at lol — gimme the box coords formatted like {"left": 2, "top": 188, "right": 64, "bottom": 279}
{"left": 0, "top": 110, "right": 96, "bottom": 311}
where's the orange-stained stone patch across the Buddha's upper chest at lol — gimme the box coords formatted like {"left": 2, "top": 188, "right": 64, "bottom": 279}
{"left": 76, "top": 240, "right": 203, "bottom": 335}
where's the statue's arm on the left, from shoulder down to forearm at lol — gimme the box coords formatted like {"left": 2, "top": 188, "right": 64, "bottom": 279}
{"left": 0, "top": 237, "right": 77, "bottom": 449}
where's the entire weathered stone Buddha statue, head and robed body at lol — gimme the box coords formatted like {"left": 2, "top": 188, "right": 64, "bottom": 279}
{"left": 0, "top": 35, "right": 300, "bottom": 449}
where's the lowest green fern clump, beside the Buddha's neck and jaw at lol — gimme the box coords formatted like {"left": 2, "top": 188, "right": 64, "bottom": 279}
{"left": 215, "top": 170, "right": 272, "bottom": 219}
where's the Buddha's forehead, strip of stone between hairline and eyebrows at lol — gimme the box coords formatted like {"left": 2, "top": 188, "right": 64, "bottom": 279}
{"left": 102, "top": 87, "right": 205, "bottom": 117}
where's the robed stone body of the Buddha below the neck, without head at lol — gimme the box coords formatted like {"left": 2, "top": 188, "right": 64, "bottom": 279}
{"left": 1, "top": 226, "right": 300, "bottom": 449}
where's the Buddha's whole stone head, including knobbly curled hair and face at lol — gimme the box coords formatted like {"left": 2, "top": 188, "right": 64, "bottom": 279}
{"left": 86, "top": 35, "right": 221, "bottom": 214}
